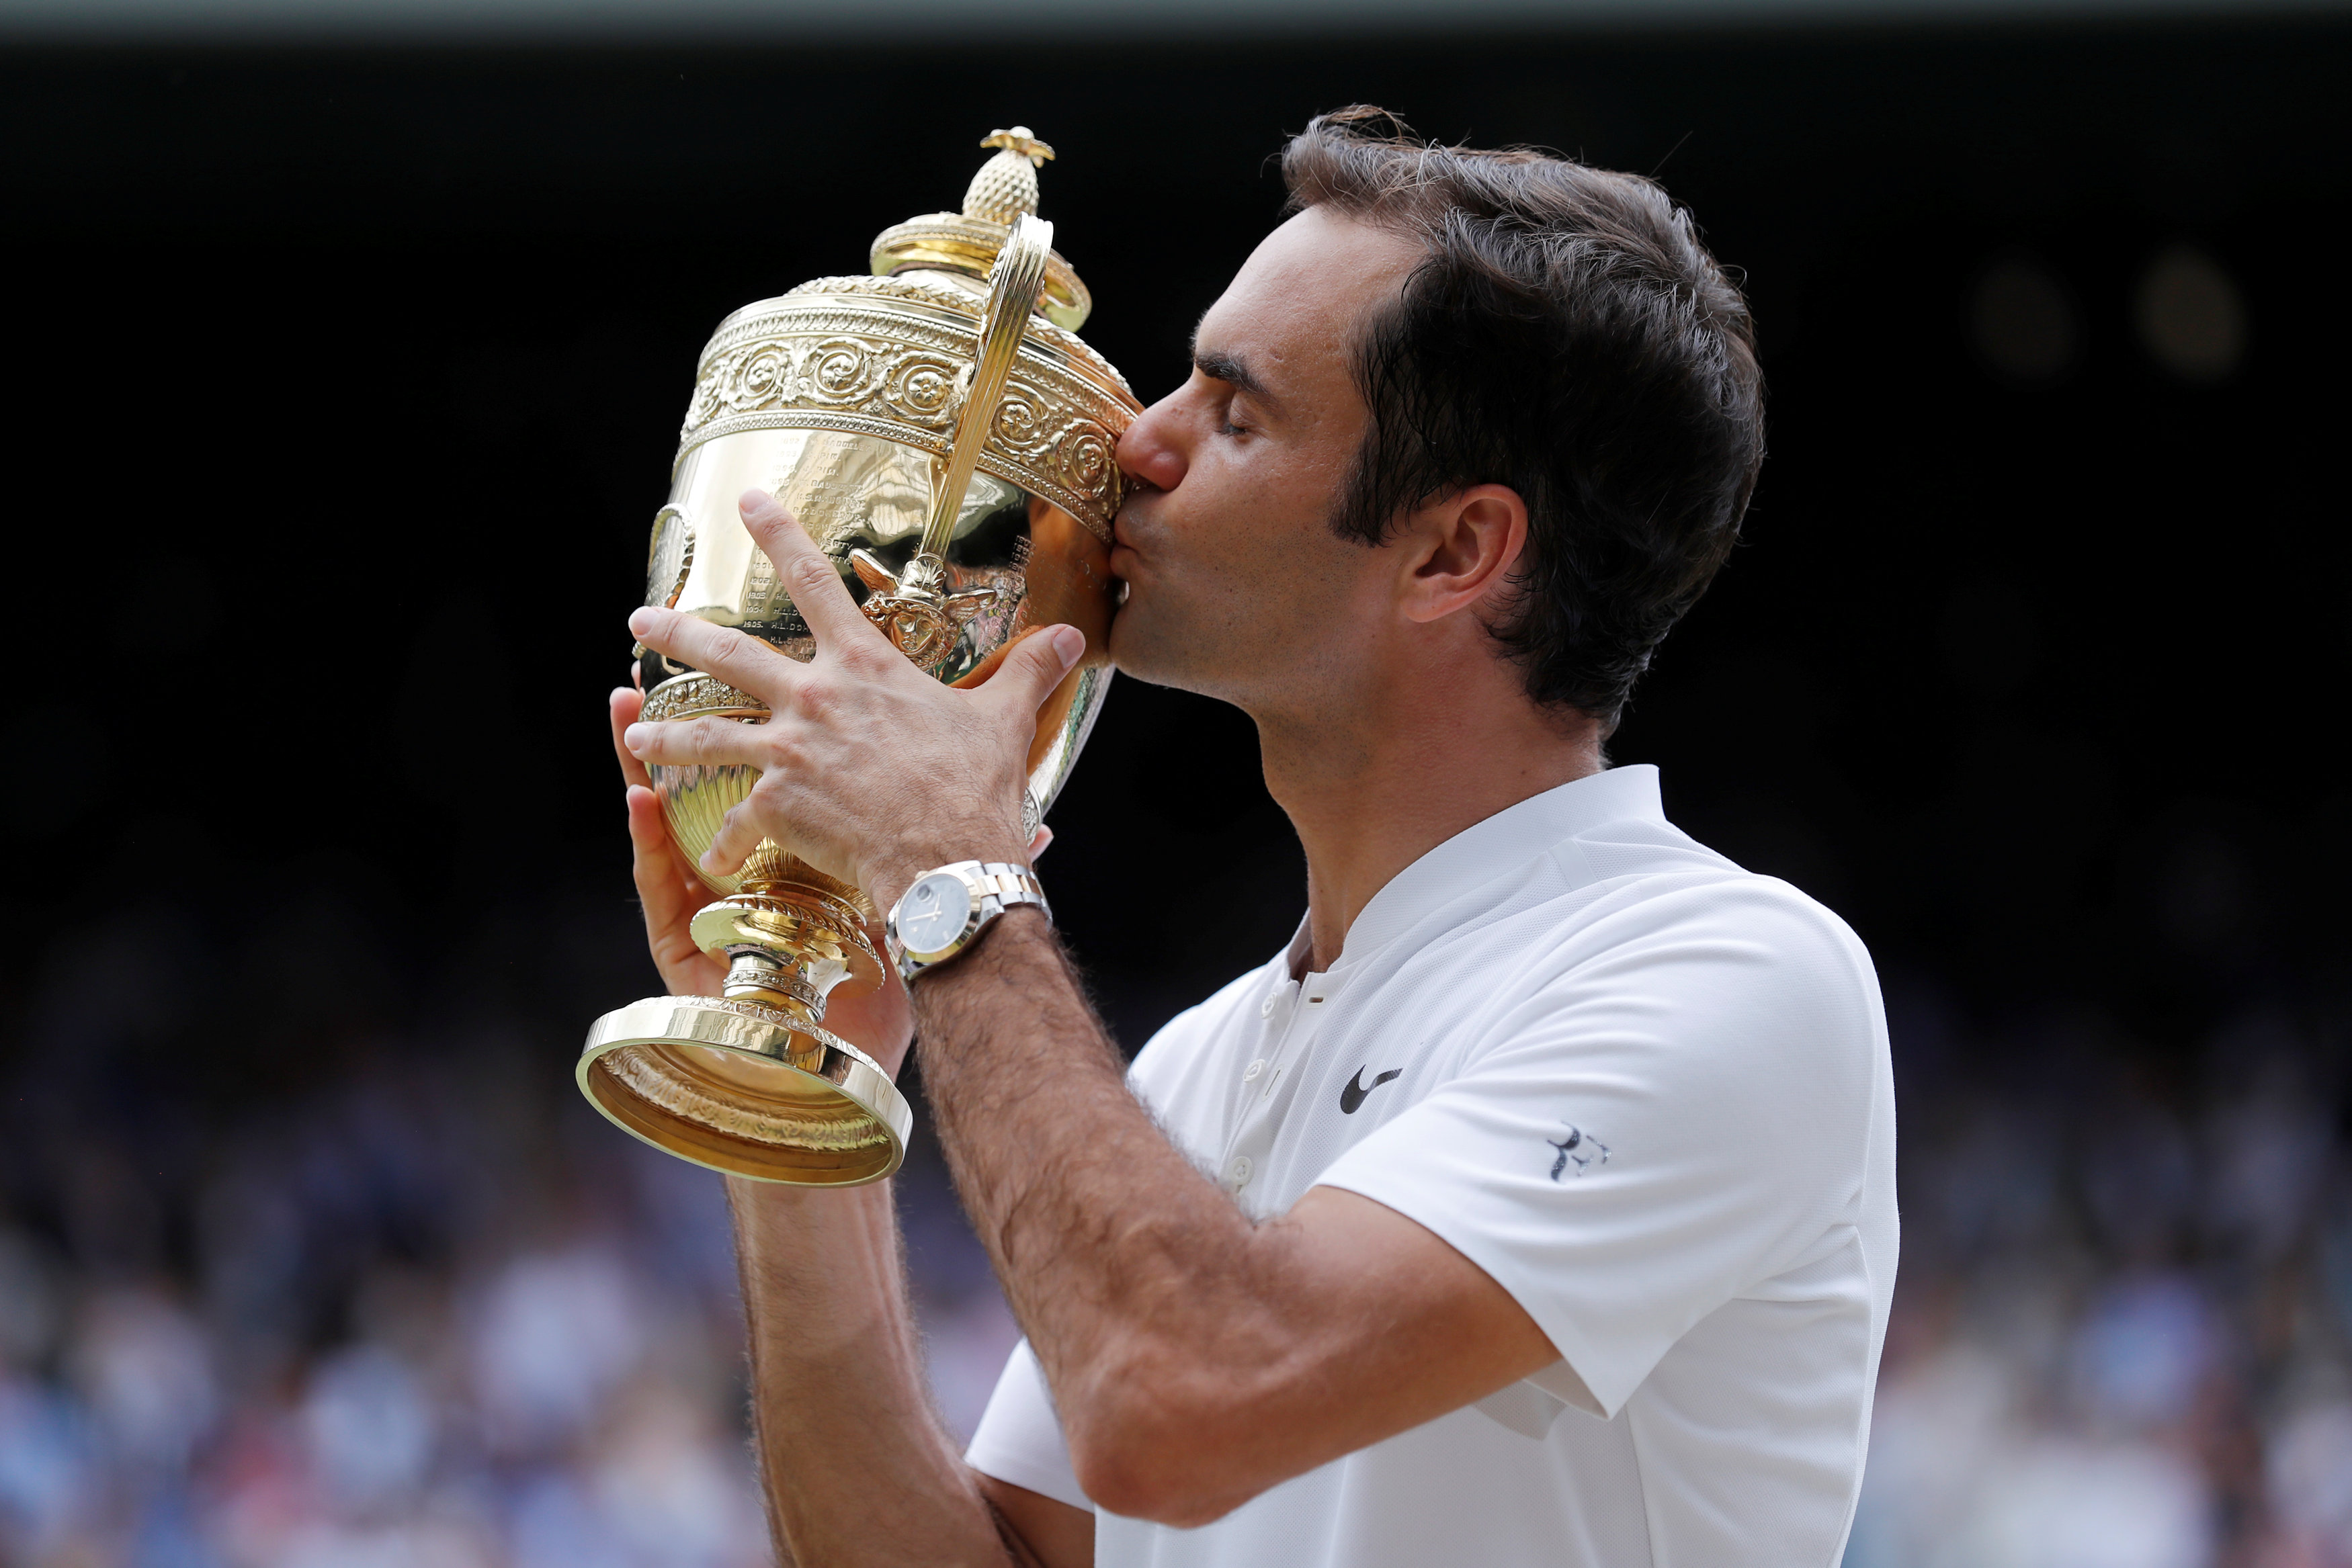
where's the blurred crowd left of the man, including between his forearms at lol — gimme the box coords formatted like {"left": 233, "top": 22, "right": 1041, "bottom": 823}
{"left": 0, "top": 1039, "right": 1019, "bottom": 1568}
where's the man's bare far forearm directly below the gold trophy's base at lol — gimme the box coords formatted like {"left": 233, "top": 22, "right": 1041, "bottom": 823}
{"left": 727, "top": 1180, "right": 1019, "bottom": 1568}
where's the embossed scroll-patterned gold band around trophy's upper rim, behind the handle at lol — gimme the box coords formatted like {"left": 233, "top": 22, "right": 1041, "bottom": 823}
{"left": 677, "top": 277, "right": 1143, "bottom": 541}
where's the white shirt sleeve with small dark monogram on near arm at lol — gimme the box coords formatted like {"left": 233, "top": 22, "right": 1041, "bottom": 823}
{"left": 1320, "top": 877, "right": 1886, "bottom": 1418}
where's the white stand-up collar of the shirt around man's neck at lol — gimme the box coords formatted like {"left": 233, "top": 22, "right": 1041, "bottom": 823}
{"left": 1336, "top": 762, "right": 1665, "bottom": 973}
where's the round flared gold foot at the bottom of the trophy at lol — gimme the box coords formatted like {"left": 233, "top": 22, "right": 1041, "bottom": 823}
{"left": 579, "top": 997, "right": 915, "bottom": 1187}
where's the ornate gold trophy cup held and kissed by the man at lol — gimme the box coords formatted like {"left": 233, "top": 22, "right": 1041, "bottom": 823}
{"left": 579, "top": 124, "right": 1141, "bottom": 1187}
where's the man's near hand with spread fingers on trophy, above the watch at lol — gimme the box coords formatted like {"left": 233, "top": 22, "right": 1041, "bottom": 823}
{"left": 626, "top": 491, "right": 1087, "bottom": 910}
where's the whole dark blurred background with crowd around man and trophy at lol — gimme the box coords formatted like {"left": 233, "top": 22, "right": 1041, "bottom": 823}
{"left": 0, "top": 5, "right": 2352, "bottom": 1568}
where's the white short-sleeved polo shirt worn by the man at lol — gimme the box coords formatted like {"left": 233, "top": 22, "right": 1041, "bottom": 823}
{"left": 969, "top": 767, "right": 1896, "bottom": 1568}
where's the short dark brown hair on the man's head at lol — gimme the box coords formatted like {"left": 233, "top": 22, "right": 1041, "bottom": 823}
{"left": 1282, "top": 103, "right": 1764, "bottom": 724}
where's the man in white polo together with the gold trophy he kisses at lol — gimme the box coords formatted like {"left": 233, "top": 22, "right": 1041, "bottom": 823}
{"left": 602, "top": 105, "right": 1900, "bottom": 1568}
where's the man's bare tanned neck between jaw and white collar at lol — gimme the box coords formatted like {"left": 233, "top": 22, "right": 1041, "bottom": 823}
{"left": 1256, "top": 682, "right": 1602, "bottom": 971}
